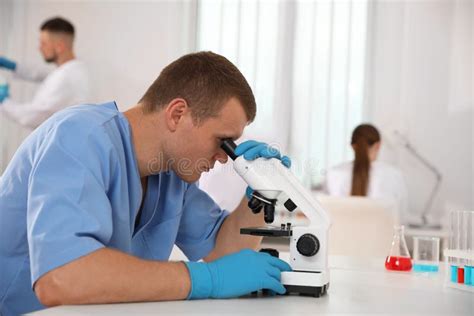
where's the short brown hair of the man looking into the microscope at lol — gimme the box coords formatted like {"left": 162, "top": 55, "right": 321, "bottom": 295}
{"left": 139, "top": 52, "right": 257, "bottom": 123}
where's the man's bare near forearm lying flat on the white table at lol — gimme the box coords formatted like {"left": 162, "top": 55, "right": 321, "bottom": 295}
{"left": 34, "top": 248, "right": 191, "bottom": 306}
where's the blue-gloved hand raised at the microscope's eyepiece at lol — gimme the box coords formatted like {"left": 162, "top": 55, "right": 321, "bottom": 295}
{"left": 235, "top": 140, "right": 291, "bottom": 200}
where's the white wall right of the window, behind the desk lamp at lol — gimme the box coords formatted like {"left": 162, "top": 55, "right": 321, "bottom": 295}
{"left": 368, "top": 0, "right": 474, "bottom": 222}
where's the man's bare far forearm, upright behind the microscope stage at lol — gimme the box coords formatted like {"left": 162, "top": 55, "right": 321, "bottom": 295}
{"left": 204, "top": 197, "right": 265, "bottom": 261}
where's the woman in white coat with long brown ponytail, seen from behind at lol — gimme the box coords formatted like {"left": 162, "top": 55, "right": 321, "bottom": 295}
{"left": 324, "top": 124, "right": 408, "bottom": 219}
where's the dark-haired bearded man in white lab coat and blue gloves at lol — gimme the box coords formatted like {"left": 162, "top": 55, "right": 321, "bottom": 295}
{"left": 0, "top": 17, "right": 90, "bottom": 128}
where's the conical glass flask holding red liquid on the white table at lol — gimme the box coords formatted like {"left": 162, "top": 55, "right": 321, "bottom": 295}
{"left": 385, "top": 226, "right": 412, "bottom": 271}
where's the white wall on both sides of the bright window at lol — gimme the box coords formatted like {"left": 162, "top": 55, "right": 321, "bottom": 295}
{"left": 0, "top": 0, "right": 474, "bottom": 226}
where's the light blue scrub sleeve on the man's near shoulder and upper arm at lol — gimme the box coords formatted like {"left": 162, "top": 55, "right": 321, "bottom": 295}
{"left": 27, "top": 122, "right": 112, "bottom": 284}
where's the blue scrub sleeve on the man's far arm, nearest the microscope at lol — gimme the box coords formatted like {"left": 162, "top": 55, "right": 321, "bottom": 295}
{"left": 176, "top": 183, "right": 229, "bottom": 261}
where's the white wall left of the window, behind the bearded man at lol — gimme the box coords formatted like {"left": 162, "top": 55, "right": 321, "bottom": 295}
{"left": 0, "top": 0, "right": 196, "bottom": 171}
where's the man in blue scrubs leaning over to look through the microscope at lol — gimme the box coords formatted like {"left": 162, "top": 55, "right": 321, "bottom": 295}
{"left": 0, "top": 52, "right": 290, "bottom": 316}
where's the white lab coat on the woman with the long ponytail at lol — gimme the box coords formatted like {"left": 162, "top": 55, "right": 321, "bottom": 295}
{"left": 324, "top": 161, "right": 408, "bottom": 221}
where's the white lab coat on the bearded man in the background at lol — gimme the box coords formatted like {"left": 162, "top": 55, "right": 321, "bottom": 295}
{"left": 0, "top": 59, "right": 90, "bottom": 128}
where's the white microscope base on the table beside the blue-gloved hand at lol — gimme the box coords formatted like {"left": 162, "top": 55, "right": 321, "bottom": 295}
{"left": 281, "top": 271, "right": 329, "bottom": 297}
